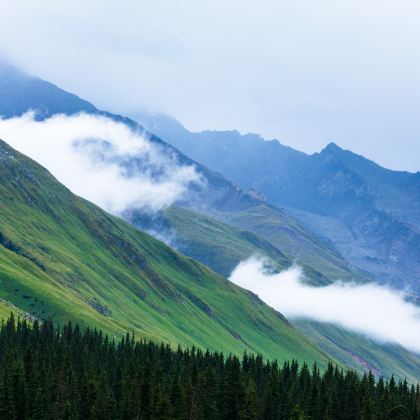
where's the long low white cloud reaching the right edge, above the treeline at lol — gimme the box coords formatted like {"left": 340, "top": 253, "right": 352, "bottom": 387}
{"left": 230, "top": 257, "right": 420, "bottom": 353}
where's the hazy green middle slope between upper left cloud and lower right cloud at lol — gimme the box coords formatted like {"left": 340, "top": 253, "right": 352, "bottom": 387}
{"left": 129, "top": 206, "right": 331, "bottom": 285}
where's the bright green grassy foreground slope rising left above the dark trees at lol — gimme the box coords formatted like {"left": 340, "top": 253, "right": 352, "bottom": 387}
{"left": 0, "top": 142, "right": 328, "bottom": 365}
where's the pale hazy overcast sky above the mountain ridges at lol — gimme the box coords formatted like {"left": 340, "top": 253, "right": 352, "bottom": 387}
{"left": 0, "top": 0, "right": 420, "bottom": 171}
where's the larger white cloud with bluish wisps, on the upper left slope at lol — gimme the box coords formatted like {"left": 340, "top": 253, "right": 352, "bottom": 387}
{"left": 0, "top": 113, "right": 201, "bottom": 214}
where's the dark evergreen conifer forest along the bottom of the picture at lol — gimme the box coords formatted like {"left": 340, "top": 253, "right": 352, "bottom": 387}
{"left": 0, "top": 316, "right": 420, "bottom": 420}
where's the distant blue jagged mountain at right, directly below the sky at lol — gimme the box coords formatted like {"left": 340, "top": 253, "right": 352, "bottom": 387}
{"left": 135, "top": 113, "right": 420, "bottom": 290}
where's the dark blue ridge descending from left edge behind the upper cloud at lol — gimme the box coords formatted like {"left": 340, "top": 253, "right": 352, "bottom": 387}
{"left": 0, "top": 65, "right": 367, "bottom": 286}
